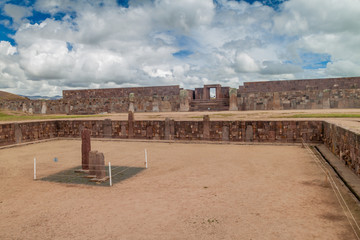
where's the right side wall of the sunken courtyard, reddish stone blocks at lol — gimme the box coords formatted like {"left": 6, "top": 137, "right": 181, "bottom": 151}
{"left": 323, "top": 122, "right": 360, "bottom": 175}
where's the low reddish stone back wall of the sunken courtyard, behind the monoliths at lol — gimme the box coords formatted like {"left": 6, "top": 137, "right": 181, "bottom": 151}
{"left": 0, "top": 119, "right": 322, "bottom": 145}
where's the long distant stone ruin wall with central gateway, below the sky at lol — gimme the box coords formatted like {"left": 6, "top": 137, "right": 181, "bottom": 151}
{"left": 0, "top": 77, "right": 360, "bottom": 114}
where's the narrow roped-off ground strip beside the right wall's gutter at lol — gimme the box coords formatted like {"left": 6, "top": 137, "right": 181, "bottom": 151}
{"left": 301, "top": 139, "right": 360, "bottom": 240}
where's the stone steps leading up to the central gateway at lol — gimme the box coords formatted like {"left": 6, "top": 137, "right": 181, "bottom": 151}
{"left": 190, "top": 98, "right": 229, "bottom": 111}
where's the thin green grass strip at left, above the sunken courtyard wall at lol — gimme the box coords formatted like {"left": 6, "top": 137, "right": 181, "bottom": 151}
{"left": 0, "top": 112, "right": 109, "bottom": 121}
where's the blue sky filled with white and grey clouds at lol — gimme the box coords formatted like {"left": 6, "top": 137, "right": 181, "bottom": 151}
{"left": 0, "top": 0, "right": 360, "bottom": 96}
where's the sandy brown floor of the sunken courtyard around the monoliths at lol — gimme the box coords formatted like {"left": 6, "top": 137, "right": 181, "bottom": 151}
{"left": 0, "top": 140, "right": 355, "bottom": 240}
